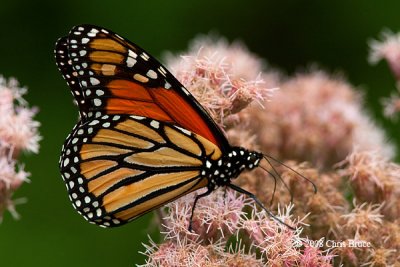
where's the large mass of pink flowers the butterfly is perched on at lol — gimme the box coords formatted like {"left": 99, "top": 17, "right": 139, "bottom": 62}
{"left": 144, "top": 34, "right": 400, "bottom": 266}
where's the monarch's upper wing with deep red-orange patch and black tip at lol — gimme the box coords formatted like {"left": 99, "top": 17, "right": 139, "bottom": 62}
{"left": 67, "top": 25, "right": 230, "bottom": 151}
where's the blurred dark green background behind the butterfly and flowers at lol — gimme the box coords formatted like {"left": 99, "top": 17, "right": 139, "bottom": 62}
{"left": 0, "top": 0, "right": 400, "bottom": 267}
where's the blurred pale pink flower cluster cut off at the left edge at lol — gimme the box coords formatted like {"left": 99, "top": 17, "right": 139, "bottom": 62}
{"left": 0, "top": 76, "right": 40, "bottom": 221}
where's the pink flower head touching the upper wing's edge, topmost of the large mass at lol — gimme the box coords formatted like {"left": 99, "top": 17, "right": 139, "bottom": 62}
{"left": 167, "top": 36, "right": 278, "bottom": 127}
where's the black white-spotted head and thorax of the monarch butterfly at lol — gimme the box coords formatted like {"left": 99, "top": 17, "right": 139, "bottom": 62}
{"left": 201, "top": 147, "right": 263, "bottom": 189}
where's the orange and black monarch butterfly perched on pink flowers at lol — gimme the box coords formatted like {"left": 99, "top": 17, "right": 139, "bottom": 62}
{"left": 54, "top": 25, "right": 314, "bottom": 230}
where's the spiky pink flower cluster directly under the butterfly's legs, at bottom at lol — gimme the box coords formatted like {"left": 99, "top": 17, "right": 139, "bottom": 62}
{"left": 139, "top": 189, "right": 332, "bottom": 266}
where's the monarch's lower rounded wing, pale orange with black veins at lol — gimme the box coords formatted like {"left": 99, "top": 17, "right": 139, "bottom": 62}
{"left": 60, "top": 115, "right": 217, "bottom": 226}
